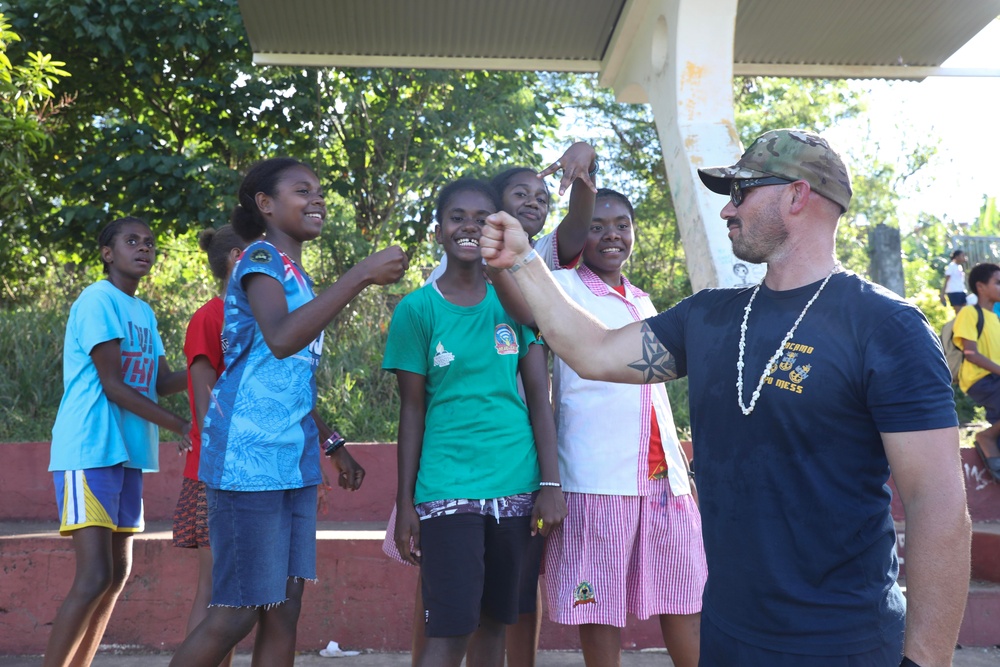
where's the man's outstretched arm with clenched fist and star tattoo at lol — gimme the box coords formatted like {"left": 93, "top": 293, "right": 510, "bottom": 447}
{"left": 480, "top": 213, "right": 677, "bottom": 384}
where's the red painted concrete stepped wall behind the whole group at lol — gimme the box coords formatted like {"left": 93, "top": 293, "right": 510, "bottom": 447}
{"left": 0, "top": 443, "right": 1000, "bottom": 653}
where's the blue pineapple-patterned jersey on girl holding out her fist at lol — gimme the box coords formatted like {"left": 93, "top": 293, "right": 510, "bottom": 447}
{"left": 198, "top": 241, "right": 323, "bottom": 491}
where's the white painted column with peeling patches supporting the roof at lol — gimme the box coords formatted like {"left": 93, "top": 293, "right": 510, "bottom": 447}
{"left": 600, "top": 0, "right": 765, "bottom": 291}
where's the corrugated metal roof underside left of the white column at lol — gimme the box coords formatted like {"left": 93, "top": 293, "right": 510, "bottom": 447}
{"left": 240, "top": 0, "right": 625, "bottom": 62}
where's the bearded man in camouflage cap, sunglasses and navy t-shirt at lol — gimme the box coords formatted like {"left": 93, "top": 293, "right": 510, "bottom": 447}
{"left": 480, "top": 130, "right": 971, "bottom": 667}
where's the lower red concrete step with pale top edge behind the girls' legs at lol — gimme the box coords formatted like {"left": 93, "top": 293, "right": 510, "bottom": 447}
{"left": 0, "top": 522, "right": 663, "bottom": 654}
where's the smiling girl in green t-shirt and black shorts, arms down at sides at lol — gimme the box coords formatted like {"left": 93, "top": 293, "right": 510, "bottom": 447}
{"left": 382, "top": 179, "right": 566, "bottom": 667}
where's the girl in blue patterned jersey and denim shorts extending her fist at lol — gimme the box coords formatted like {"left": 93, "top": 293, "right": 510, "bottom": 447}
{"left": 170, "top": 158, "right": 407, "bottom": 667}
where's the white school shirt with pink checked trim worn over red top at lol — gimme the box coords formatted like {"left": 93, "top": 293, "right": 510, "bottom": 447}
{"left": 541, "top": 265, "right": 691, "bottom": 496}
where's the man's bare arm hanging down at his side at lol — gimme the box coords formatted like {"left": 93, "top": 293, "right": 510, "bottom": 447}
{"left": 882, "top": 428, "right": 972, "bottom": 667}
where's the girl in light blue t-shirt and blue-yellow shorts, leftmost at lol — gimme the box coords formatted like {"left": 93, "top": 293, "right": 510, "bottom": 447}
{"left": 42, "top": 217, "right": 191, "bottom": 667}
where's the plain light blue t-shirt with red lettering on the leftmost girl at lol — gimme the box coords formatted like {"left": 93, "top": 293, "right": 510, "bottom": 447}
{"left": 49, "top": 280, "right": 163, "bottom": 472}
